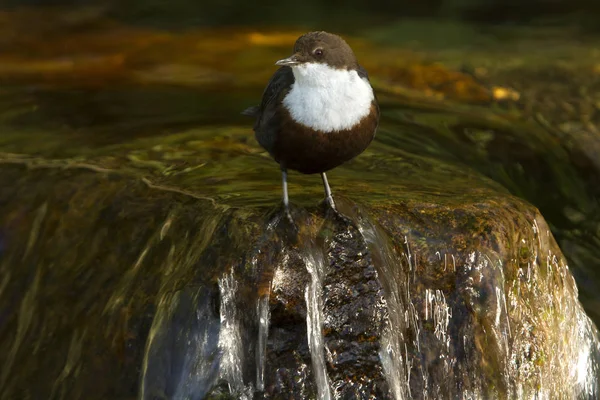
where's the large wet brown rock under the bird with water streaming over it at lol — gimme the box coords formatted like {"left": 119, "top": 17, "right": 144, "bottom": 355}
{"left": 0, "top": 155, "right": 600, "bottom": 399}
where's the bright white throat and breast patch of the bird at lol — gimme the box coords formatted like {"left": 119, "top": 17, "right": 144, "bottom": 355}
{"left": 283, "top": 63, "right": 374, "bottom": 132}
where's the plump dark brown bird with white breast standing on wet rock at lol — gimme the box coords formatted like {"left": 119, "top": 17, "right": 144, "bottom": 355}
{"left": 243, "top": 32, "right": 379, "bottom": 217}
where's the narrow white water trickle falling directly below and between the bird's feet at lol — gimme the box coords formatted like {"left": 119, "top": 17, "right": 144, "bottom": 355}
{"left": 302, "top": 245, "right": 331, "bottom": 400}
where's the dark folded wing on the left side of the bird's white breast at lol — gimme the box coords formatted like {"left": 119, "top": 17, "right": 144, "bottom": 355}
{"left": 254, "top": 67, "right": 294, "bottom": 152}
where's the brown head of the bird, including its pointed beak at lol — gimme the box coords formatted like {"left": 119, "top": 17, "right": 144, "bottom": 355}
{"left": 275, "top": 31, "right": 358, "bottom": 69}
